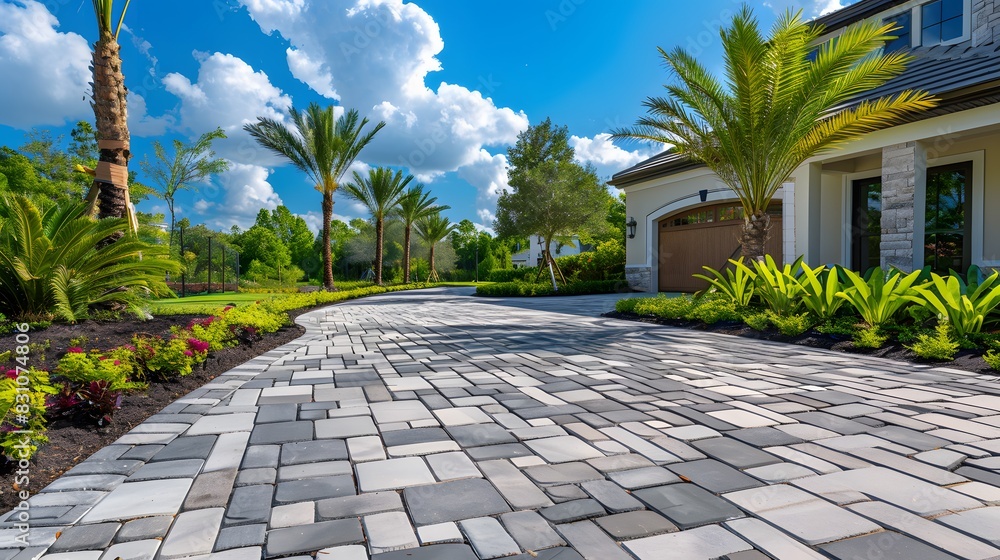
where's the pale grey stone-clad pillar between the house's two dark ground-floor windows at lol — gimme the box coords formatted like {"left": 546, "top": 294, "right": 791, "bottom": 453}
{"left": 880, "top": 142, "right": 926, "bottom": 271}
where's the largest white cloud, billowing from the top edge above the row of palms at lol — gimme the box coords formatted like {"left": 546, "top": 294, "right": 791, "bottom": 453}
{"left": 241, "top": 0, "right": 528, "bottom": 180}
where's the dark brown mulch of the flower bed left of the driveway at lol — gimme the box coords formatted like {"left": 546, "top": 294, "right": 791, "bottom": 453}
{"left": 0, "top": 309, "right": 309, "bottom": 512}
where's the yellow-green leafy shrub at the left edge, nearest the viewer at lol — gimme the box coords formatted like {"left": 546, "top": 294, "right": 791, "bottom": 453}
{"left": 0, "top": 368, "right": 56, "bottom": 461}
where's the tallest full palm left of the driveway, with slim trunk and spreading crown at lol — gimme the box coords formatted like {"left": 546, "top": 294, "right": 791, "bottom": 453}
{"left": 243, "top": 103, "right": 385, "bottom": 290}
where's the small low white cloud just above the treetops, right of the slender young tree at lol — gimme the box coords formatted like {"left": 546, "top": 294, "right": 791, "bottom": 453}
{"left": 194, "top": 162, "right": 281, "bottom": 229}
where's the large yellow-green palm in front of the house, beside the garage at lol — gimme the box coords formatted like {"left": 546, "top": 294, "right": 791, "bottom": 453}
{"left": 613, "top": 6, "right": 935, "bottom": 259}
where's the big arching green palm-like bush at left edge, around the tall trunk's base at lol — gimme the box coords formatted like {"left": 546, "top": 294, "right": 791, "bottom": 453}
{"left": 0, "top": 196, "right": 178, "bottom": 321}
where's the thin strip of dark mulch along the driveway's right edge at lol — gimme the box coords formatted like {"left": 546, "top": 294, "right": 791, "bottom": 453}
{"left": 603, "top": 311, "right": 1000, "bottom": 375}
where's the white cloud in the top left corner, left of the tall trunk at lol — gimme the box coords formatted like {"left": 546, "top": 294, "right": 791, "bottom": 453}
{"left": 0, "top": 0, "right": 93, "bottom": 129}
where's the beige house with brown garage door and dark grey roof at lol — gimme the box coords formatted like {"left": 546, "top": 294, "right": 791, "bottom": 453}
{"left": 610, "top": 0, "right": 1000, "bottom": 292}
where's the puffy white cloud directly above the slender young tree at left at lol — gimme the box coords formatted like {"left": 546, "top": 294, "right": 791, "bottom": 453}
{"left": 163, "top": 52, "right": 292, "bottom": 165}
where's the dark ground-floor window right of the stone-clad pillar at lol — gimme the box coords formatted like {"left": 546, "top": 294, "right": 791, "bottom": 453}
{"left": 924, "top": 162, "right": 972, "bottom": 274}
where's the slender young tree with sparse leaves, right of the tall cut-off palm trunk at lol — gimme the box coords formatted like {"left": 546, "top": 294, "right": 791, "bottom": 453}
{"left": 140, "top": 128, "right": 229, "bottom": 247}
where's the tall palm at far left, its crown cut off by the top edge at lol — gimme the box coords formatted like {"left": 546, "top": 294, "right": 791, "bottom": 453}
{"left": 87, "top": 0, "right": 138, "bottom": 240}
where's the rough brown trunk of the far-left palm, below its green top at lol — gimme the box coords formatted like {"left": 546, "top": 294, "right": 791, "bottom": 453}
{"left": 91, "top": 32, "right": 132, "bottom": 239}
